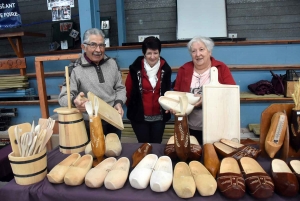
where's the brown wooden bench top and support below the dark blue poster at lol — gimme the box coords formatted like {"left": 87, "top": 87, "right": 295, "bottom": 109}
{"left": 0, "top": 31, "right": 46, "bottom": 75}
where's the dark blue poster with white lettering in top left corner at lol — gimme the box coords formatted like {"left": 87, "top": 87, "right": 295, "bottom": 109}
{"left": 0, "top": 0, "right": 22, "bottom": 30}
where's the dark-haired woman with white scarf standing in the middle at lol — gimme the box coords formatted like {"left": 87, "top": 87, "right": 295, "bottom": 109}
{"left": 125, "top": 36, "right": 172, "bottom": 143}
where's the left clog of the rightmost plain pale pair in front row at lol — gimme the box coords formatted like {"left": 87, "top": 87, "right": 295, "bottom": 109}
{"left": 173, "top": 162, "right": 196, "bottom": 198}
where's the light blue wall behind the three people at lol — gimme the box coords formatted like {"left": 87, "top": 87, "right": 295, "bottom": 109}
{"left": 1, "top": 44, "right": 300, "bottom": 127}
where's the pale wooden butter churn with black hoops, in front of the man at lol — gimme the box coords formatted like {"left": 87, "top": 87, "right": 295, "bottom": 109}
{"left": 54, "top": 107, "right": 89, "bottom": 154}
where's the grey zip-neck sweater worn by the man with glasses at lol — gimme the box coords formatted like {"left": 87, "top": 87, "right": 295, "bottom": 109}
{"left": 58, "top": 55, "right": 126, "bottom": 107}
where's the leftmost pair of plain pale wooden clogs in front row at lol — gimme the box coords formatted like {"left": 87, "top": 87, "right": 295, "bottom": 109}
{"left": 47, "top": 153, "right": 93, "bottom": 186}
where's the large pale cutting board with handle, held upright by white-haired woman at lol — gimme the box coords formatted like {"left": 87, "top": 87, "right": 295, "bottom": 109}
{"left": 202, "top": 67, "right": 240, "bottom": 144}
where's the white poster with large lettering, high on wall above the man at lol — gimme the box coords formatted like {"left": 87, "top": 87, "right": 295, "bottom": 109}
{"left": 47, "top": 0, "right": 74, "bottom": 21}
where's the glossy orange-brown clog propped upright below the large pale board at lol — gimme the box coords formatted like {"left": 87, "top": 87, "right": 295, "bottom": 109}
{"left": 203, "top": 143, "right": 220, "bottom": 178}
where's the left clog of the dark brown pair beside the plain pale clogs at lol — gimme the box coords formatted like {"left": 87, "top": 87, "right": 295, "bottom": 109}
{"left": 217, "top": 157, "right": 245, "bottom": 199}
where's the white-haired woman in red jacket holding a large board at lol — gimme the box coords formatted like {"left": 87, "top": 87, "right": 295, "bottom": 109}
{"left": 174, "top": 36, "right": 235, "bottom": 144}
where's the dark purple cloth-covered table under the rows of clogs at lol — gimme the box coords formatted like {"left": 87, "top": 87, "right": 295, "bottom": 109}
{"left": 0, "top": 143, "right": 300, "bottom": 201}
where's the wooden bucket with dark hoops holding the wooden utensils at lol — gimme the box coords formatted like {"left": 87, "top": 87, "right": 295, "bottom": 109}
{"left": 8, "top": 148, "right": 47, "bottom": 185}
